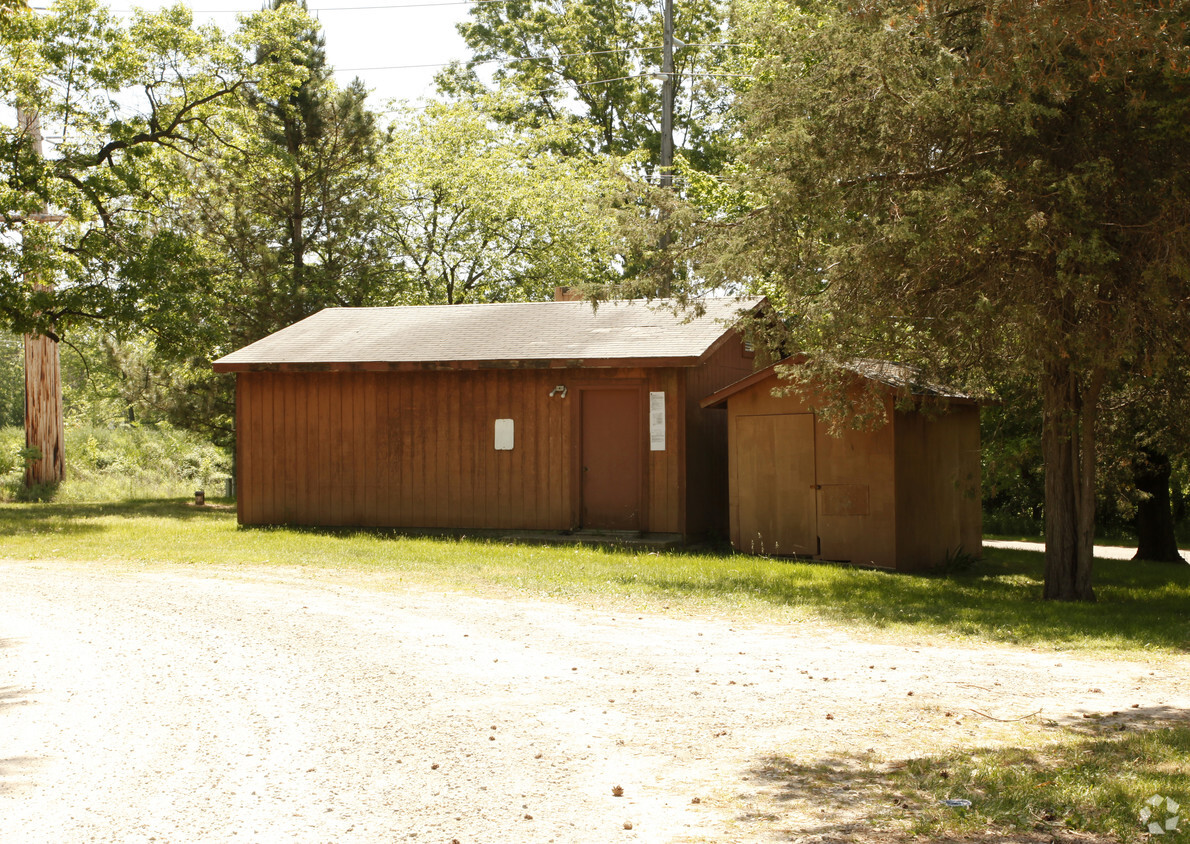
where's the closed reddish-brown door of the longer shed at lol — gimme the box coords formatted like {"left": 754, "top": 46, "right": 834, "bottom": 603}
{"left": 581, "top": 389, "right": 645, "bottom": 531}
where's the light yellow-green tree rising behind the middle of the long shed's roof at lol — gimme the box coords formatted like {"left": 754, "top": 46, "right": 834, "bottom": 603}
{"left": 381, "top": 102, "right": 624, "bottom": 304}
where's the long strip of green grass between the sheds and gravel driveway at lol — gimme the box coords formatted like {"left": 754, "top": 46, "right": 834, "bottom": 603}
{"left": 0, "top": 500, "right": 1190, "bottom": 655}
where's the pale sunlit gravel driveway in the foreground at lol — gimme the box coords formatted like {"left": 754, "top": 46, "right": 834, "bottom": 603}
{"left": 0, "top": 562, "right": 1190, "bottom": 844}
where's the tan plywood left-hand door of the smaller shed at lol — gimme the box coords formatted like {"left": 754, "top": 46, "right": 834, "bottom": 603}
{"left": 734, "top": 413, "right": 818, "bottom": 556}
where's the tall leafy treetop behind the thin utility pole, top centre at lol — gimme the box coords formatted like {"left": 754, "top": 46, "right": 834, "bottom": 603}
{"left": 440, "top": 0, "right": 733, "bottom": 170}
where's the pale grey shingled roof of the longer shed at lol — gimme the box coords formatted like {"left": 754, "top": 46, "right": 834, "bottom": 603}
{"left": 214, "top": 299, "right": 760, "bottom": 373}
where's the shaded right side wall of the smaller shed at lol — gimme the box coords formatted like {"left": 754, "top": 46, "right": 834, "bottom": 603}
{"left": 896, "top": 405, "right": 983, "bottom": 569}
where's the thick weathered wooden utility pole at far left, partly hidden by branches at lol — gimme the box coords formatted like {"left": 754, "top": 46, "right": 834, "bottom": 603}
{"left": 17, "top": 107, "right": 65, "bottom": 487}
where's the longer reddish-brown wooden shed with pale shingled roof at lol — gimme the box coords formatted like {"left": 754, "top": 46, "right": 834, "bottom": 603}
{"left": 214, "top": 299, "right": 757, "bottom": 537}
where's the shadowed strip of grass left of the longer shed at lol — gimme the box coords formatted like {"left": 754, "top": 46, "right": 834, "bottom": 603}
{"left": 0, "top": 499, "right": 236, "bottom": 536}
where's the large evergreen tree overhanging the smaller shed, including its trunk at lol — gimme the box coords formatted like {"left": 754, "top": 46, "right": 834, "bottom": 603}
{"left": 707, "top": 0, "right": 1190, "bottom": 600}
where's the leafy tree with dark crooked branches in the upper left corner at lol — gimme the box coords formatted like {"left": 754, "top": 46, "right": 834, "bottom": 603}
{"left": 0, "top": 0, "right": 302, "bottom": 333}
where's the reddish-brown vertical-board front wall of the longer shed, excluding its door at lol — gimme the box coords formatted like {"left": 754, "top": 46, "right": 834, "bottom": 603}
{"left": 237, "top": 368, "right": 694, "bottom": 533}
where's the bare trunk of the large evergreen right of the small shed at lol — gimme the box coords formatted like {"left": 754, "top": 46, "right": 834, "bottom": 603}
{"left": 1041, "top": 361, "right": 1103, "bottom": 601}
